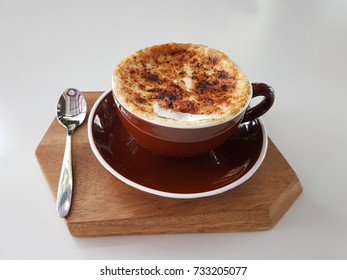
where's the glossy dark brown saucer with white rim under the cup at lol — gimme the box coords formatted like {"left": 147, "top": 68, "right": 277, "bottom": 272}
{"left": 88, "top": 91, "right": 267, "bottom": 198}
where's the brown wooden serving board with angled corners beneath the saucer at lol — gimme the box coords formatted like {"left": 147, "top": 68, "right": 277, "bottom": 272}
{"left": 36, "top": 92, "right": 302, "bottom": 236}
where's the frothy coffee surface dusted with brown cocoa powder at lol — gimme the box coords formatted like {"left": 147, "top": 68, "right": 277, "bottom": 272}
{"left": 112, "top": 43, "right": 251, "bottom": 127}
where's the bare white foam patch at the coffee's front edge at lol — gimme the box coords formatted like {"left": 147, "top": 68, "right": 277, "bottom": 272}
{"left": 153, "top": 103, "right": 218, "bottom": 123}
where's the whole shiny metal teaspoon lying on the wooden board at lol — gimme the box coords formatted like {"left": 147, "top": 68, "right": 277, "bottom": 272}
{"left": 56, "top": 88, "right": 87, "bottom": 218}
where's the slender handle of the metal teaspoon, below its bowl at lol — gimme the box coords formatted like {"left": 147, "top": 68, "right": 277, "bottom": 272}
{"left": 56, "top": 129, "right": 73, "bottom": 218}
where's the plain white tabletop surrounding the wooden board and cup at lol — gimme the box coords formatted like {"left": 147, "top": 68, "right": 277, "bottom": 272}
{"left": 0, "top": 0, "right": 347, "bottom": 259}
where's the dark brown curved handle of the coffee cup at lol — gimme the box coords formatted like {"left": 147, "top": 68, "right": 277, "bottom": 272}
{"left": 242, "top": 83, "right": 275, "bottom": 122}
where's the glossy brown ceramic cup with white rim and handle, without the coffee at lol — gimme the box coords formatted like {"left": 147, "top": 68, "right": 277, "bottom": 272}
{"left": 113, "top": 44, "right": 275, "bottom": 158}
